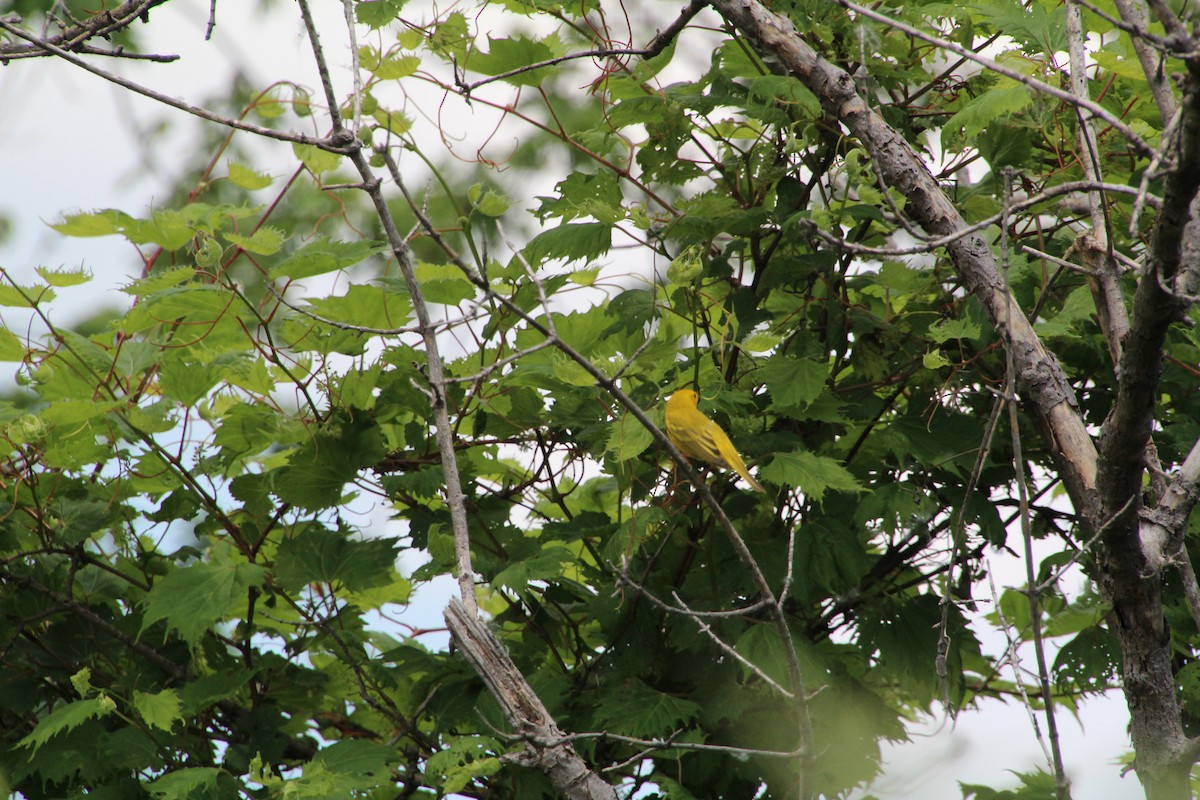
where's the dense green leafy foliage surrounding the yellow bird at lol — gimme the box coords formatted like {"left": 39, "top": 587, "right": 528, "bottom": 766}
{"left": 0, "top": 0, "right": 1200, "bottom": 800}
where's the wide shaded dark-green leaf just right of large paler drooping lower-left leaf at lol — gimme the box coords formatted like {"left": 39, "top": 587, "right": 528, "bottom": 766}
{"left": 275, "top": 525, "right": 396, "bottom": 591}
